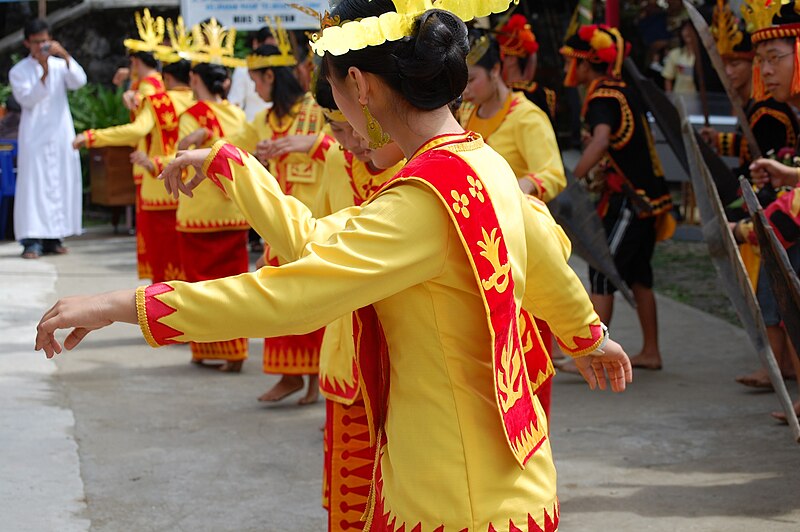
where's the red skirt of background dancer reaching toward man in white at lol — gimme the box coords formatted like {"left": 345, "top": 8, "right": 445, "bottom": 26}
{"left": 139, "top": 209, "right": 186, "bottom": 283}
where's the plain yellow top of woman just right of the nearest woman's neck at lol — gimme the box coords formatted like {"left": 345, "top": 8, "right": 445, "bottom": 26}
{"left": 460, "top": 92, "right": 567, "bottom": 201}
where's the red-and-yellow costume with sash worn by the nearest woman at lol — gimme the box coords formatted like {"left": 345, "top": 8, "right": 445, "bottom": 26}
{"left": 137, "top": 134, "right": 604, "bottom": 531}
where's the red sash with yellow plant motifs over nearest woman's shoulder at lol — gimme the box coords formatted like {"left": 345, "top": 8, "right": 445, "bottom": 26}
{"left": 354, "top": 143, "right": 547, "bottom": 467}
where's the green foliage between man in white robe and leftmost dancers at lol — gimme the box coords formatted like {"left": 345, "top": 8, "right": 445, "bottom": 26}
{"left": 69, "top": 84, "right": 130, "bottom": 132}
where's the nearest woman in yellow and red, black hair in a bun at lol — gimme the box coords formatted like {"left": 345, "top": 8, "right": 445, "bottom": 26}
{"left": 36, "top": 0, "right": 632, "bottom": 532}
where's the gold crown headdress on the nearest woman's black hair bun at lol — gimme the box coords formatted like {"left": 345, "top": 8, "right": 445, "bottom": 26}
{"left": 311, "top": 0, "right": 519, "bottom": 55}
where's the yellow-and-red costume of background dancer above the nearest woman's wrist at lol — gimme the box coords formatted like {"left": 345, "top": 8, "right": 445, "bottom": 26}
{"left": 176, "top": 101, "right": 250, "bottom": 361}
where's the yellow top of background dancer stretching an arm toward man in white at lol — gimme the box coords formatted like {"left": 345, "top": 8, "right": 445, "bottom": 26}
{"left": 84, "top": 88, "right": 194, "bottom": 210}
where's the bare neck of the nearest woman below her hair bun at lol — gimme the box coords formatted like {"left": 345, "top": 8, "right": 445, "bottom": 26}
{"left": 381, "top": 107, "right": 464, "bottom": 159}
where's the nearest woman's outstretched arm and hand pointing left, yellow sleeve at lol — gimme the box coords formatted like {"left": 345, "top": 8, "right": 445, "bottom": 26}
{"left": 36, "top": 180, "right": 451, "bottom": 356}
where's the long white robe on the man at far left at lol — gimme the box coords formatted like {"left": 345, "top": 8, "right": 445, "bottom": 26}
{"left": 8, "top": 56, "right": 86, "bottom": 240}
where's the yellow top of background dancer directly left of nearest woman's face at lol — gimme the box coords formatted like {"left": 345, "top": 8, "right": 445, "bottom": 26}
{"left": 227, "top": 93, "right": 333, "bottom": 207}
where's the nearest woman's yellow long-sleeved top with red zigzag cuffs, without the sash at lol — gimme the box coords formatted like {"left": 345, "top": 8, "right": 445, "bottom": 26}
{"left": 137, "top": 137, "right": 599, "bottom": 530}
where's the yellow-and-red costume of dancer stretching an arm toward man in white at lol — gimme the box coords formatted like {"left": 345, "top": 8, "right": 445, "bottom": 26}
{"left": 84, "top": 88, "right": 194, "bottom": 282}
